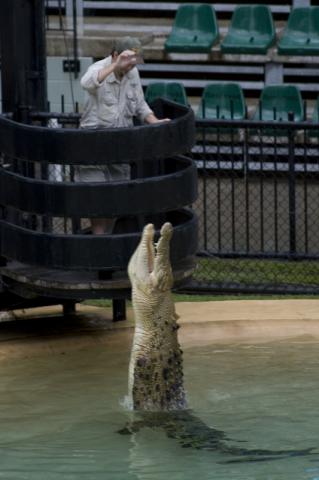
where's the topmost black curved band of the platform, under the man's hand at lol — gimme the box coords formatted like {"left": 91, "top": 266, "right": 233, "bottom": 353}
{"left": 0, "top": 100, "right": 194, "bottom": 165}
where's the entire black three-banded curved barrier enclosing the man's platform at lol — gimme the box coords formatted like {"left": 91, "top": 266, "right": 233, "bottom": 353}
{"left": 0, "top": 100, "right": 197, "bottom": 276}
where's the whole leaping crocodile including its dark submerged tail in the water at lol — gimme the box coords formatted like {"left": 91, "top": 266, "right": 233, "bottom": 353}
{"left": 124, "top": 223, "right": 313, "bottom": 463}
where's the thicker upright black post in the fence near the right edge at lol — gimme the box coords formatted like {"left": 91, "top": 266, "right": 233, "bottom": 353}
{"left": 288, "top": 112, "right": 296, "bottom": 254}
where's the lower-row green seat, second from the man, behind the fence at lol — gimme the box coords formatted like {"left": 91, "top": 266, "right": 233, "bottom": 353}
{"left": 197, "top": 83, "right": 246, "bottom": 120}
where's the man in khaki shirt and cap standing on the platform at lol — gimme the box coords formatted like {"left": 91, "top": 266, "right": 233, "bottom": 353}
{"left": 77, "top": 37, "right": 169, "bottom": 234}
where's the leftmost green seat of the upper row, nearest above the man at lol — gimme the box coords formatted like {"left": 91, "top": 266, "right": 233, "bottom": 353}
{"left": 165, "top": 4, "right": 219, "bottom": 53}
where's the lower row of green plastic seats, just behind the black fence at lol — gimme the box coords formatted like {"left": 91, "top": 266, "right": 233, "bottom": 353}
{"left": 145, "top": 82, "right": 312, "bottom": 122}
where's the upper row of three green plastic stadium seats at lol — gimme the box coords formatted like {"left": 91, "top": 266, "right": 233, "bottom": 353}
{"left": 165, "top": 4, "right": 319, "bottom": 55}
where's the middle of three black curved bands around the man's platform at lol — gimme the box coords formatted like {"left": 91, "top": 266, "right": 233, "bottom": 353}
{"left": 0, "top": 156, "right": 197, "bottom": 217}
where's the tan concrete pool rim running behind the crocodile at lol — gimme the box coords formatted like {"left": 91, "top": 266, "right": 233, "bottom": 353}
{"left": 0, "top": 299, "right": 319, "bottom": 361}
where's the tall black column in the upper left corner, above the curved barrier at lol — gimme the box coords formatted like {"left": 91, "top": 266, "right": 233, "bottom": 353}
{"left": 0, "top": 0, "right": 47, "bottom": 121}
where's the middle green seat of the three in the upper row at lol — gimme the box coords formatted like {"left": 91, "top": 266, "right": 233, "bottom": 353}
{"left": 221, "top": 5, "right": 276, "bottom": 54}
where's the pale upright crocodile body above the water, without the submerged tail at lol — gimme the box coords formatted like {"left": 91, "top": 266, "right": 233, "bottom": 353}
{"left": 128, "top": 222, "right": 187, "bottom": 411}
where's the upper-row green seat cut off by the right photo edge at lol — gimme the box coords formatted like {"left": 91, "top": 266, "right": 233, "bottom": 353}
{"left": 278, "top": 7, "right": 319, "bottom": 55}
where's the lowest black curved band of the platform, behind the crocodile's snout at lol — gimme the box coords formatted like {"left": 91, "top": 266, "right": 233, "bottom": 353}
{"left": 0, "top": 210, "right": 197, "bottom": 270}
